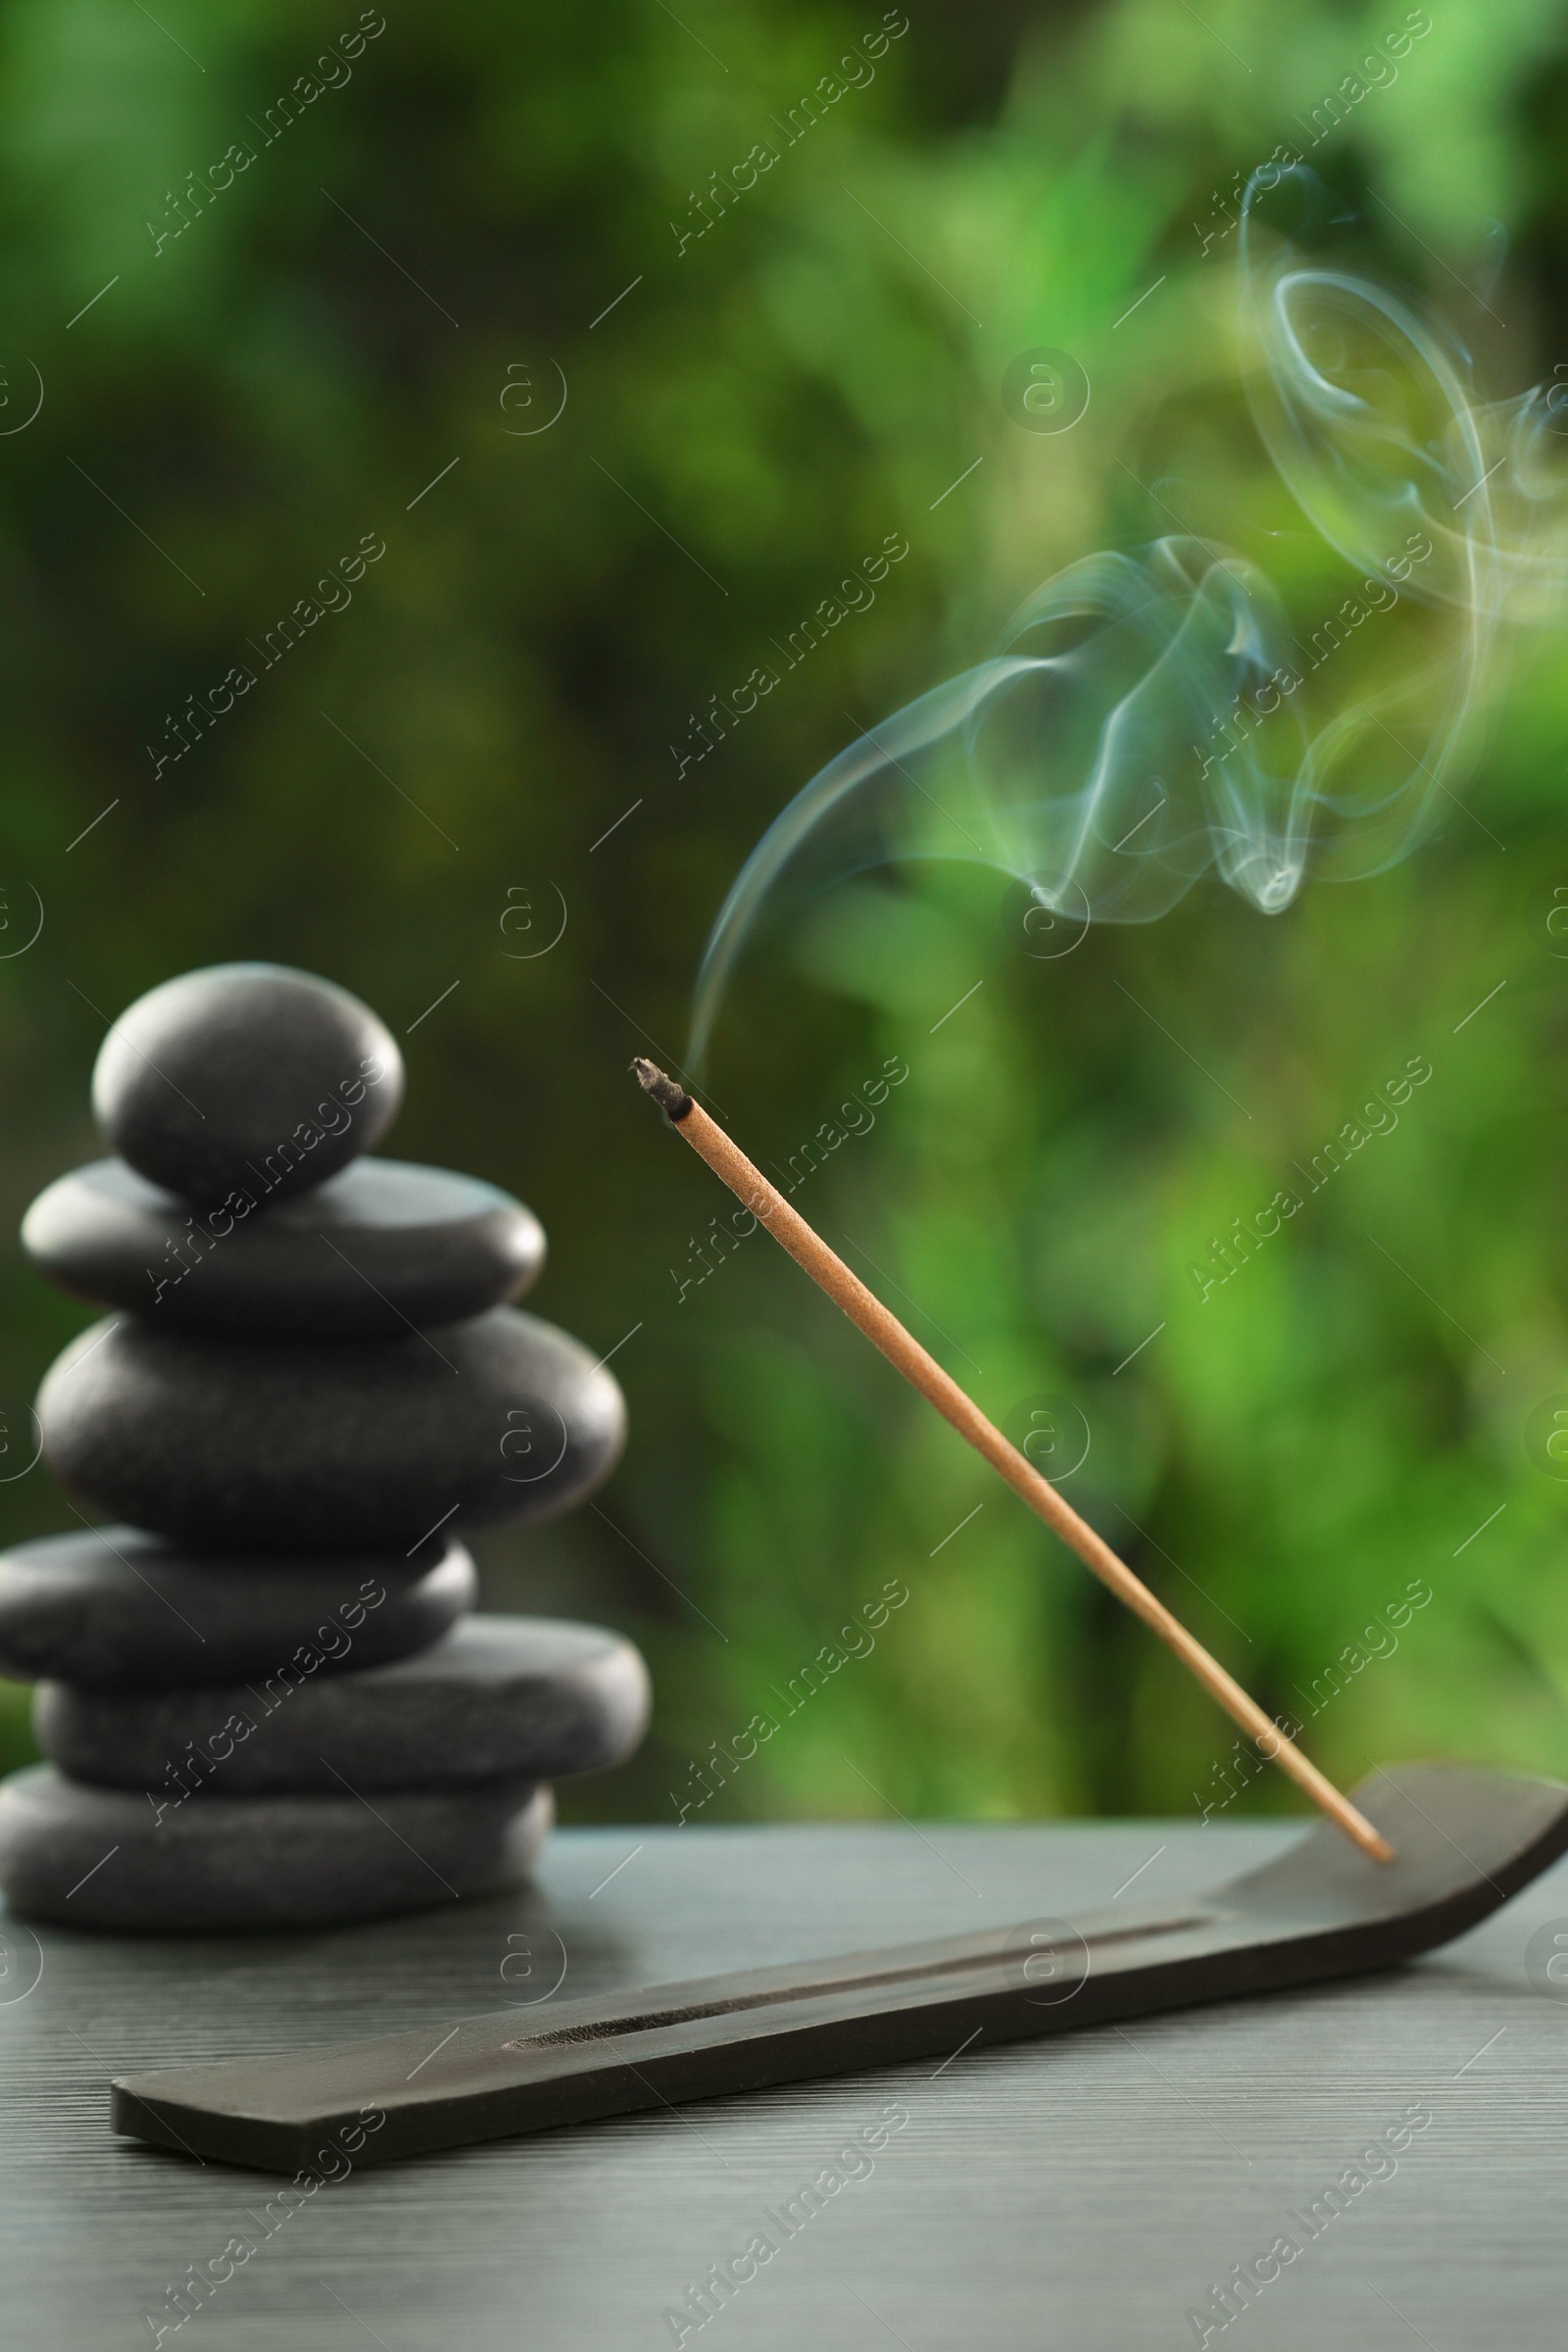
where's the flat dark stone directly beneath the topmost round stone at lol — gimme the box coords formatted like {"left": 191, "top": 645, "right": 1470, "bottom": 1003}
{"left": 22, "top": 1159, "right": 546, "bottom": 1336}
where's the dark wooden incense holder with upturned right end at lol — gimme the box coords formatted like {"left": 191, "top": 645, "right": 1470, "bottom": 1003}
{"left": 111, "top": 1764, "right": 1568, "bottom": 2174}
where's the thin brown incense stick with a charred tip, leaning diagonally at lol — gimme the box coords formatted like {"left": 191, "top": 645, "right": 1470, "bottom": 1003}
{"left": 632, "top": 1056, "right": 1394, "bottom": 1863}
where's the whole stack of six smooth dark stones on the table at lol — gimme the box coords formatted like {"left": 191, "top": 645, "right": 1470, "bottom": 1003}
{"left": 0, "top": 964, "right": 649, "bottom": 1929}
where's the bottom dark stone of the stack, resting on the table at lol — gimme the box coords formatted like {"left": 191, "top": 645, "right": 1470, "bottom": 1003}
{"left": 0, "top": 1764, "right": 553, "bottom": 1936}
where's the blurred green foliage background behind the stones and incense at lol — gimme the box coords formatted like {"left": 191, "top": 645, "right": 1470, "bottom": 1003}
{"left": 0, "top": 0, "right": 1568, "bottom": 1821}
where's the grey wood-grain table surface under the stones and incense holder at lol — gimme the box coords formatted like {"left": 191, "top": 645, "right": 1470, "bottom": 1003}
{"left": 0, "top": 1823, "right": 1568, "bottom": 2352}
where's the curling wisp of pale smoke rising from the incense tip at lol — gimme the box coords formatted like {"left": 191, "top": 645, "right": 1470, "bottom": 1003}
{"left": 691, "top": 167, "right": 1568, "bottom": 1063}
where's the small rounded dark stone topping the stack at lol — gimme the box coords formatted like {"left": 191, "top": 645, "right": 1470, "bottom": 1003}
{"left": 92, "top": 964, "right": 402, "bottom": 1201}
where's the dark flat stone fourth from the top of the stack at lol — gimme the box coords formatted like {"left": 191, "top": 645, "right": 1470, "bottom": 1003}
{"left": 0, "top": 1527, "right": 479, "bottom": 1689}
